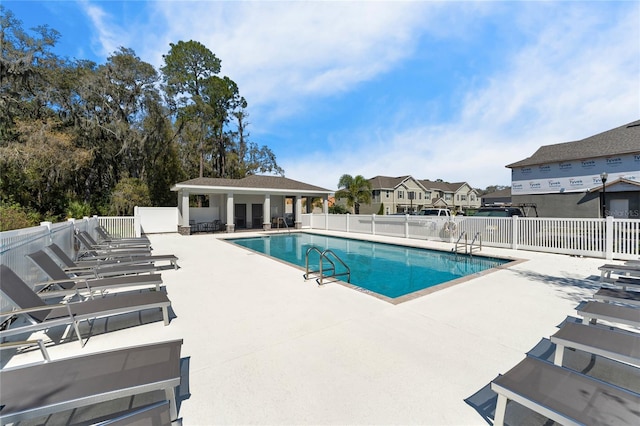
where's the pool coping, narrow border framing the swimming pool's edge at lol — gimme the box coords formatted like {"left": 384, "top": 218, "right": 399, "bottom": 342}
{"left": 219, "top": 229, "right": 528, "bottom": 305}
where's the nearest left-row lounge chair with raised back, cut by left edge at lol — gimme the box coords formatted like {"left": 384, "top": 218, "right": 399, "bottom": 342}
{"left": 0, "top": 265, "right": 171, "bottom": 346}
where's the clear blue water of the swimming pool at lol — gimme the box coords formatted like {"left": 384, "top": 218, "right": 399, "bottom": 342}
{"left": 230, "top": 232, "right": 510, "bottom": 298}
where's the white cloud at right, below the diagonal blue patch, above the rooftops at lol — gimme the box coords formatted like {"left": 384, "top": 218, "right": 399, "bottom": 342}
{"left": 283, "top": 2, "right": 640, "bottom": 189}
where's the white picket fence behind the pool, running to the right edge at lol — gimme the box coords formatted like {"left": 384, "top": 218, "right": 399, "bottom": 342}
{"left": 302, "top": 213, "right": 640, "bottom": 260}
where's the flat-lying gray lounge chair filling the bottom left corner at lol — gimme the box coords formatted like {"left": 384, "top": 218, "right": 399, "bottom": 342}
{"left": 0, "top": 340, "right": 182, "bottom": 425}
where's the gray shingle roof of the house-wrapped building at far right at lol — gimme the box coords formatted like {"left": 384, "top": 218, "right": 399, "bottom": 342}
{"left": 506, "top": 120, "right": 640, "bottom": 168}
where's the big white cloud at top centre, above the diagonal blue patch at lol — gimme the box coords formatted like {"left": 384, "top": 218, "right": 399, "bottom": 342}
{"left": 145, "top": 1, "right": 439, "bottom": 120}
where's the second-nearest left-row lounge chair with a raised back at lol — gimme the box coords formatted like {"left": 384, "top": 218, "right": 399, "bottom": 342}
{"left": 27, "top": 250, "right": 162, "bottom": 297}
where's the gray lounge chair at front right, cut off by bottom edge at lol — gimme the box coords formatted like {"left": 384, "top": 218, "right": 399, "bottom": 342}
{"left": 491, "top": 357, "right": 640, "bottom": 426}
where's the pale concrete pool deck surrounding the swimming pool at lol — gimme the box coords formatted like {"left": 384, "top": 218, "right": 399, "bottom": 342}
{"left": 3, "top": 232, "right": 624, "bottom": 425}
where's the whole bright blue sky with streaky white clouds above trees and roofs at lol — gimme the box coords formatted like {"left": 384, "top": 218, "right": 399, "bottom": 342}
{"left": 2, "top": 0, "right": 640, "bottom": 189}
